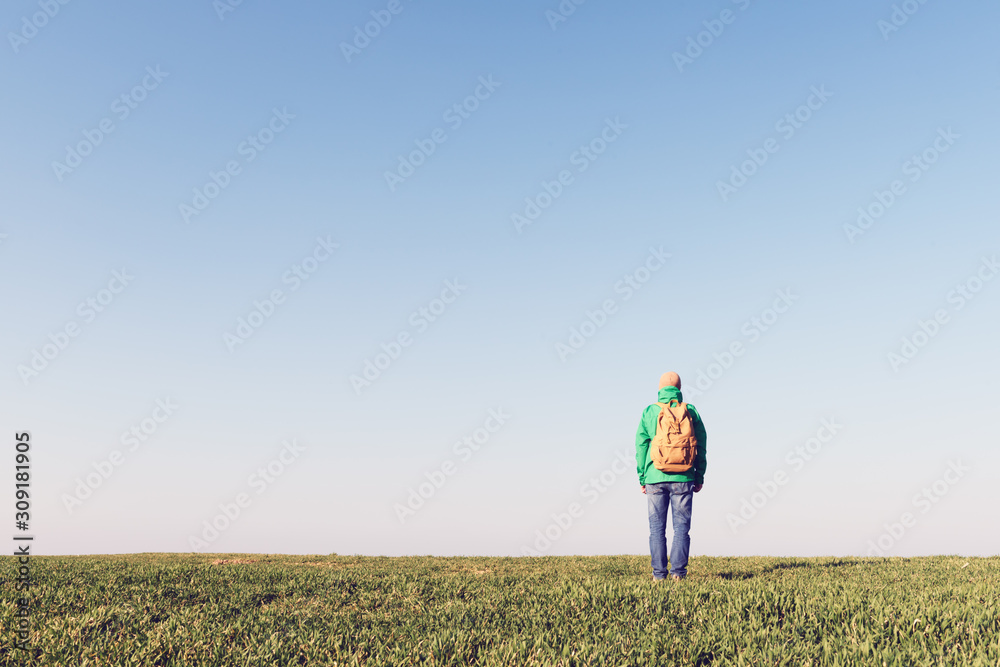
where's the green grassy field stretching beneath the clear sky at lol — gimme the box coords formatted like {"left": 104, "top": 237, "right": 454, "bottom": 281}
{"left": 0, "top": 554, "right": 1000, "bottom": 667}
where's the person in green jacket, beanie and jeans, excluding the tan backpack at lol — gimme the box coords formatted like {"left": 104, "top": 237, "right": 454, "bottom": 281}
{"left": 635, "top": 373, "right": 708, "bottom": 581}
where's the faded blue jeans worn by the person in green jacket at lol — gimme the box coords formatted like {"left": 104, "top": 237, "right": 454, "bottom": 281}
{"left": 646, "top": 482, "right": 694, "bottom": 578}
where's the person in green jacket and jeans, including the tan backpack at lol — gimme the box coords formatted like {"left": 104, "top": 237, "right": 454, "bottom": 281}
{"left": 635, "top": 373, "right": 708, "bottom": 581}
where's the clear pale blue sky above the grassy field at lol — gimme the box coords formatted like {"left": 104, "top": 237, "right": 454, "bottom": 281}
{"left": 0, "top": 0, "right": 1000, "bottom": 556}
